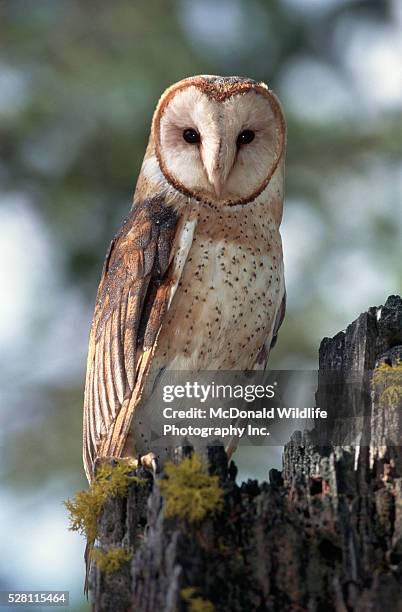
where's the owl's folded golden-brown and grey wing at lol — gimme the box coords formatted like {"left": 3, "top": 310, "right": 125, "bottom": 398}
{"left": 83, "top": 198, "right": 192, "bottom": 480}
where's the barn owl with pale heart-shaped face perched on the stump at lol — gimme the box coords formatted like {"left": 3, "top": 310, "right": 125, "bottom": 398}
{"left": 83, "top": 76, "right": 286, "bottom": 481}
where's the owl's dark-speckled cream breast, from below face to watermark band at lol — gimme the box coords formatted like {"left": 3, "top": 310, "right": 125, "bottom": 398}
{"left": 154, "top": 203, "right": 284, "bottom": 370}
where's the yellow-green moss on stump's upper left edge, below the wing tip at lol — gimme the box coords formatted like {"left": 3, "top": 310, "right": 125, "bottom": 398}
{"left": 65, "top": 462, "right": 141, "bottom": 543}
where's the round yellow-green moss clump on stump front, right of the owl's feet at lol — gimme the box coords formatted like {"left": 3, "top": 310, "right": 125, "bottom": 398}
{"left": 160, "top": 454, "right": 223, "bottom": 523}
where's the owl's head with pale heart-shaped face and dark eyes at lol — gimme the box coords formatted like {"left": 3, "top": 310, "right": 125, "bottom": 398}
{"left": 152, "top": 76, "right": 286, "bottom": 205}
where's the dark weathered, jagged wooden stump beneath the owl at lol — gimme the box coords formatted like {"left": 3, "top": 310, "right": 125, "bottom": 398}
{"left": 92, "top": 296, "right": 402, "bottom": 612}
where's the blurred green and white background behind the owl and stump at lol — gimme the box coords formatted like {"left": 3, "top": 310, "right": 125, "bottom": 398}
{"left": 0, "top": 0, "right": 402, "bottom": 610}
